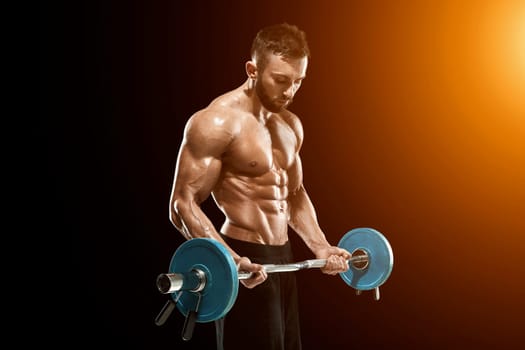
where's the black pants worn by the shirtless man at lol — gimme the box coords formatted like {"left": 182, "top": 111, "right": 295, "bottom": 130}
{"left": 215, "top": 235, "right": 301, "bottom": 350}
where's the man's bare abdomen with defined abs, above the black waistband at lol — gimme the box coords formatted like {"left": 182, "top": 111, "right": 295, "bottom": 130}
{"left": 214, "top": 169, "right": 289, "bottom": 245}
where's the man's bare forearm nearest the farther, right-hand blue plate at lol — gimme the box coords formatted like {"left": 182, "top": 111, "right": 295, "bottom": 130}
{"left": 288, "top": 186, "right": 330, "bottom": 253}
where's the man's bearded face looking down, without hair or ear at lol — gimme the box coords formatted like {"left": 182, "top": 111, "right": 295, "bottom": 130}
{"left": 255, "top": 54, "right": 308, "bottom": 113}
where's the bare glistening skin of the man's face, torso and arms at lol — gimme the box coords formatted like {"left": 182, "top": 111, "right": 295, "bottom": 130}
{"left": 170, "top": 54, "right": 351, "bottom": 288}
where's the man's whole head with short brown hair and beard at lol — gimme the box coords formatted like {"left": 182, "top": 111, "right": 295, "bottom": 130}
{"left": 246, "top": 23, "right": 310, "bottom": 113}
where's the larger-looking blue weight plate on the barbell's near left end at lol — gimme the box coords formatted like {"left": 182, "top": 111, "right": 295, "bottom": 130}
{"left": 169, "top": 238, "right": 239, "bottom": 322}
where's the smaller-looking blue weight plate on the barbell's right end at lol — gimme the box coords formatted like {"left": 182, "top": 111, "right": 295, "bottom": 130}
{"left": 338, "top": 227, "right": 394, "bottom": 290}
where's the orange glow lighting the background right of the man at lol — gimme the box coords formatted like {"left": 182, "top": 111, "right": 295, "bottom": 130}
{"left": 294, "top": 1, "right": 525, "bottom": 348}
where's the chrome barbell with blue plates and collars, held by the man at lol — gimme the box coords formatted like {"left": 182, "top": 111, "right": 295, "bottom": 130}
{"left": 155, "top": 228, "right": 394, "bottom": 340}
